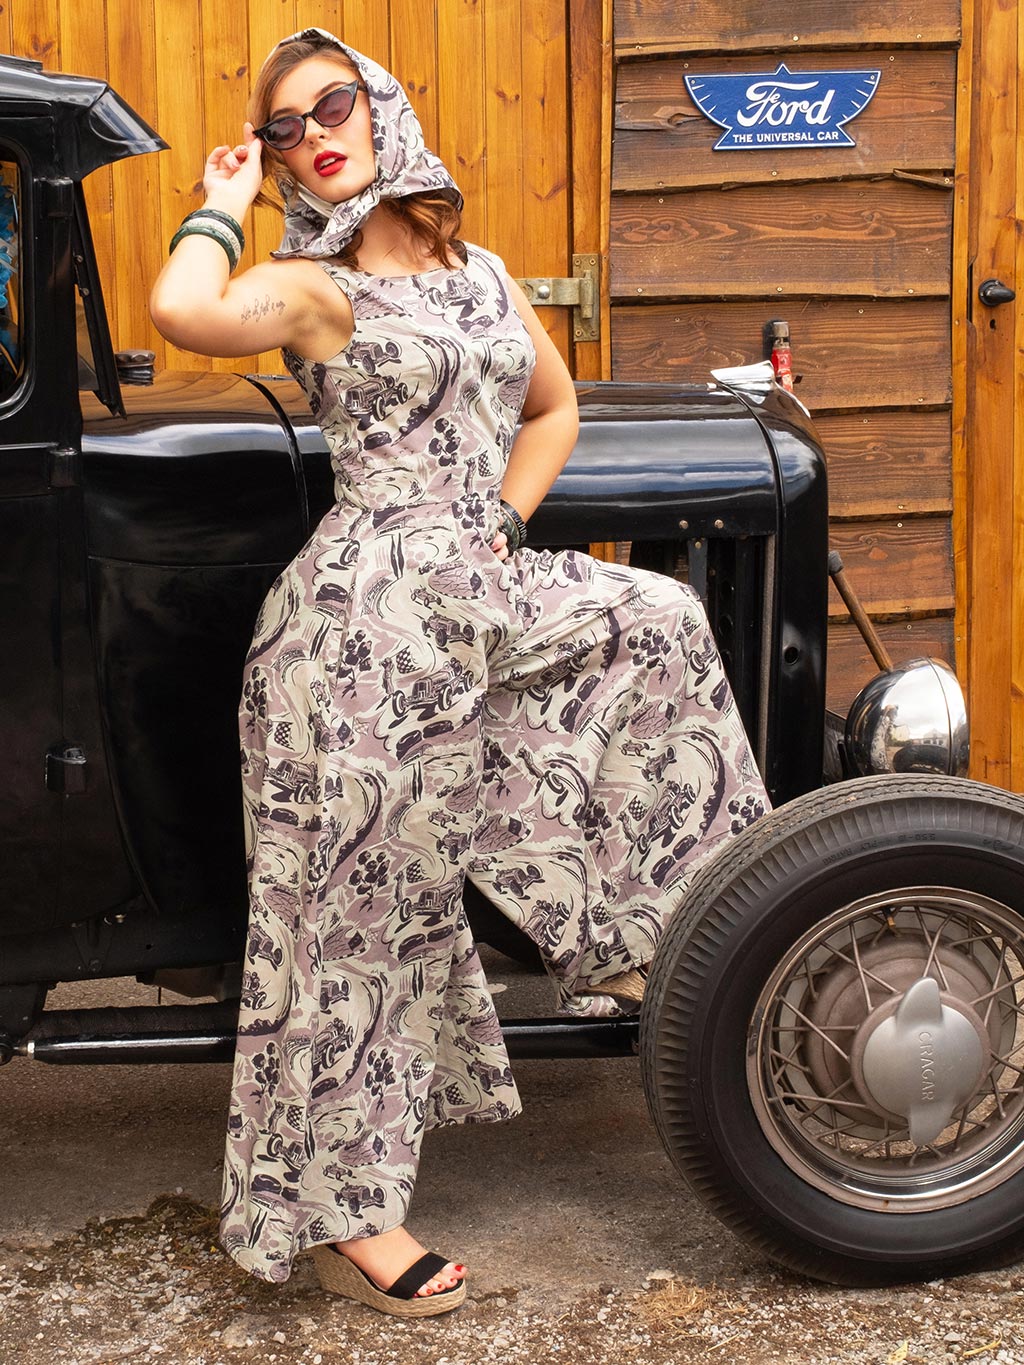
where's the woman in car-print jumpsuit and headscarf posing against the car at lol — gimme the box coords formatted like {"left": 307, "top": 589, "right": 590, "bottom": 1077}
{"left": 152, "top": 29, "right": 766, "bottom": 1314}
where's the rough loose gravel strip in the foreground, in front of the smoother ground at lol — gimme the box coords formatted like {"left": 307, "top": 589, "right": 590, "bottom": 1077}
{"left": 0, "top": 1196, "right": 1024, "bottom": 1365}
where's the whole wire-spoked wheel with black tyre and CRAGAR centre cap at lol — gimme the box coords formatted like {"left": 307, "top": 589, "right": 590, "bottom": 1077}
{"left": 640, "top": 775, "right": 1024, "bottom": 1284}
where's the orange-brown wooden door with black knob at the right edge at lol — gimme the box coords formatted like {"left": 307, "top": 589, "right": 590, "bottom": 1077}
{"left": 954, "top": 0, "right": 1024, "bottom": 790}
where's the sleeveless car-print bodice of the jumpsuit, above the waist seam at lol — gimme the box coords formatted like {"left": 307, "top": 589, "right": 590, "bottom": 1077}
{"left": 284, "top": 246, "right": 535, "bottom": 520}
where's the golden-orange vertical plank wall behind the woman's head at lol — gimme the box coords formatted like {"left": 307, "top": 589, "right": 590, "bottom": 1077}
{"left": 0, "top": 0, "right": 573, "bottom": 371}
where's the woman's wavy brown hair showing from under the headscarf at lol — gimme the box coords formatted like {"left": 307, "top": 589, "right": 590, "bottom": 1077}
{"left": 248, "top": 38, "right": 466, "bottom": 269}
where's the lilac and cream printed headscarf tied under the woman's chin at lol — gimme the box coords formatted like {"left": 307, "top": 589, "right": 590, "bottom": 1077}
{"left": 260, "top": 29, "right": 463, "bottom": 261}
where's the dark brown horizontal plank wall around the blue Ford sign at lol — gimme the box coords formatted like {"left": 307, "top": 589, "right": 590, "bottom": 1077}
{"left": 610, "top": 0, "right": 960, "bottom": 708}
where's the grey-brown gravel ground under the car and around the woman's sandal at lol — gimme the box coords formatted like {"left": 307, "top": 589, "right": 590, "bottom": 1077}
{"left": 0, "top": 973, "right": 1024, "bottom": 1365}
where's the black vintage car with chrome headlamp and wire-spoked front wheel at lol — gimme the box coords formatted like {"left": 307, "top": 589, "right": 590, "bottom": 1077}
{"left": 0, "top": 59, "right": 1024, "bottom": 1283}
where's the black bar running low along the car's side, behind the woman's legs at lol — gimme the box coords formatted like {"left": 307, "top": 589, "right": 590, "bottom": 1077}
{"left": 14, "top": 1001, "right": 640, "bottom": 1066}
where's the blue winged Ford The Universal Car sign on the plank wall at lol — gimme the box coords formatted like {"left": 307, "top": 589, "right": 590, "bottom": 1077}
{"left": 685, "top": 61, "right": 882, "bottom": 152}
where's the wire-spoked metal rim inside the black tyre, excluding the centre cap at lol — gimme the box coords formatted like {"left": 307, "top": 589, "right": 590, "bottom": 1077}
{"left": 747, "top": 887, "right": 1024, "bottom": 1213}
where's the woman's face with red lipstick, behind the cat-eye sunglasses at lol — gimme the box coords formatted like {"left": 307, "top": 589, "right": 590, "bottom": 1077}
{"left": 268, "top": 57, "right": 377, "bottom": 203}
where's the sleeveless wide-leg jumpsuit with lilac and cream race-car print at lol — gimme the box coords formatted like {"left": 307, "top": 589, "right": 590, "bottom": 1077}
{"left": 221, "top": 247, "right": 767, "bottom": 1280}
